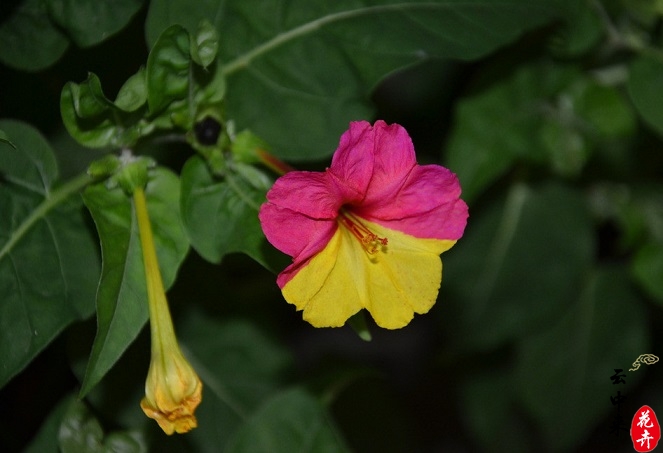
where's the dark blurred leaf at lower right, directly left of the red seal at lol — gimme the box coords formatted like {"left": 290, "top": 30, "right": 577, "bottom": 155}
{"left": 513, "top": 267, "right": 650, "bottom": 451}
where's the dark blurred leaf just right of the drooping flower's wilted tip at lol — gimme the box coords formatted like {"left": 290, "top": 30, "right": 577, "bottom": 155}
{"left": 177, "top": 312, "right": 292, "bottom": 452}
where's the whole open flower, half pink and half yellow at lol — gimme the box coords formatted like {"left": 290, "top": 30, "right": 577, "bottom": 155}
{"left": 260, "top": 121, "right": 468, "bottom": 329}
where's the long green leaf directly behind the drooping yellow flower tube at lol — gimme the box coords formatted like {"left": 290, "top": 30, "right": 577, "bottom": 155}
{"left": 81, "top": 168, "right": 189, "bottom": 395}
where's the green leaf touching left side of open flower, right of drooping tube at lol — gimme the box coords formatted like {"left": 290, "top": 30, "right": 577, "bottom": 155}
{"left": 181, "top": 156, "right": 285, "bottom": 271}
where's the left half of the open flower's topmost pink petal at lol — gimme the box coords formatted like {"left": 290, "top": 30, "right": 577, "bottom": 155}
{"left": 327, "top": 121, "right": 375, "bottom": 203}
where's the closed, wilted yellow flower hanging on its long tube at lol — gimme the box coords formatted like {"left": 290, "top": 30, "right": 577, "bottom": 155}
{"left": 133, "top": 188, "right": 203, "bottom": 435}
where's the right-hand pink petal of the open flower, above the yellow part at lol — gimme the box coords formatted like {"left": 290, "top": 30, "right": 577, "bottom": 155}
{"left": 353, "top": 165, "right": 468, "bottom": 240}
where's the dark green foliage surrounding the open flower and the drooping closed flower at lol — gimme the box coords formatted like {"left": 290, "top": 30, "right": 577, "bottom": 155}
{"left": 0, "top": 0, "right": 663, "bottom": 452}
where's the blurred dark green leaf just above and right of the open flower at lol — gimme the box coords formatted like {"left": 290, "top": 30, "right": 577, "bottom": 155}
{"left": 446, "top": 62, "right": 579, "bottom": 203}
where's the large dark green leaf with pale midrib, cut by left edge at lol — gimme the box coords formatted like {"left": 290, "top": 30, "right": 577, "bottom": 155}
{"left": 0, "top": 120, "right": 99, "bottom": 387}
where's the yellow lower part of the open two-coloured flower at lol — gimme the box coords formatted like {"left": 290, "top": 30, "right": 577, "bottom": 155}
{"left": 283, "top": 220, "right": 456, "bottom": 329}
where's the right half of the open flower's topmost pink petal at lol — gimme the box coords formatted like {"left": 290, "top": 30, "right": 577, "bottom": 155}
{"left": 361, "top": 121, "right": 417, "bottom": 205}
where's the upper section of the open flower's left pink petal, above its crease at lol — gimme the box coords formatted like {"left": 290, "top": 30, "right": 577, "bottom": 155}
{"left": 267, "top": 171, "right": 344, "bottom": 219}
